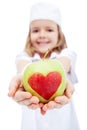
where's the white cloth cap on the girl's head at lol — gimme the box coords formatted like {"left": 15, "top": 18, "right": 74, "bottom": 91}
{"left": 30, "top": 3, "right": 61, "bottom": 25}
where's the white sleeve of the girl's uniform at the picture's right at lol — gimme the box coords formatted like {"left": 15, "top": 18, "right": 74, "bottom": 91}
{"left": 59, "top": 48, "right": 78, "bottom": 83}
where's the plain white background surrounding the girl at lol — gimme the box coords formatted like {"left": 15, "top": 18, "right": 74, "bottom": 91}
{"left": 0, "top": 0, "right": 87, "bottom": 130}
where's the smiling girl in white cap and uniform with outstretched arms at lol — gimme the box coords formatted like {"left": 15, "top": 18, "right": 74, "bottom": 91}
{"left": 8, "top": 3, "right": 80, "bottom": 130}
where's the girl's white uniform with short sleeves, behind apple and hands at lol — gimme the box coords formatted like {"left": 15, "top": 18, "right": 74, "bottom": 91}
{"left": 16, "top": 48, "right": 80, "bottom": 130}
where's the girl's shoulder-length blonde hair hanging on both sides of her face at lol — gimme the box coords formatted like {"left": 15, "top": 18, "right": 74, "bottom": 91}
{"left": 24, "top": 26, "right": 67, "bottom": 57}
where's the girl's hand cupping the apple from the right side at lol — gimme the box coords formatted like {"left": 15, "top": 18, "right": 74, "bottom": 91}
{"left": 41, "top": 81, "right": 74, "bottom": 115}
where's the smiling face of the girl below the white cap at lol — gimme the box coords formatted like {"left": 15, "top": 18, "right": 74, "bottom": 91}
{"left": 30, "top": 20, "right": 58, "bottom": 54}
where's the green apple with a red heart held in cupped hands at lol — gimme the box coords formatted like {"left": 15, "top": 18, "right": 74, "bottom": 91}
{"left": 22, "top": 59, "right": 66, "bottom": 103}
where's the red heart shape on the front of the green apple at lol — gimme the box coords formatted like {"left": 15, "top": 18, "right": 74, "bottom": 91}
{"left": 28, "top": 72, "right": 62, "bottom": 100}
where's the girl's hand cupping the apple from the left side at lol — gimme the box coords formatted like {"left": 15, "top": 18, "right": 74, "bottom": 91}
{"left": 8, "top": 75, "right": 40, "bottom": 109}
